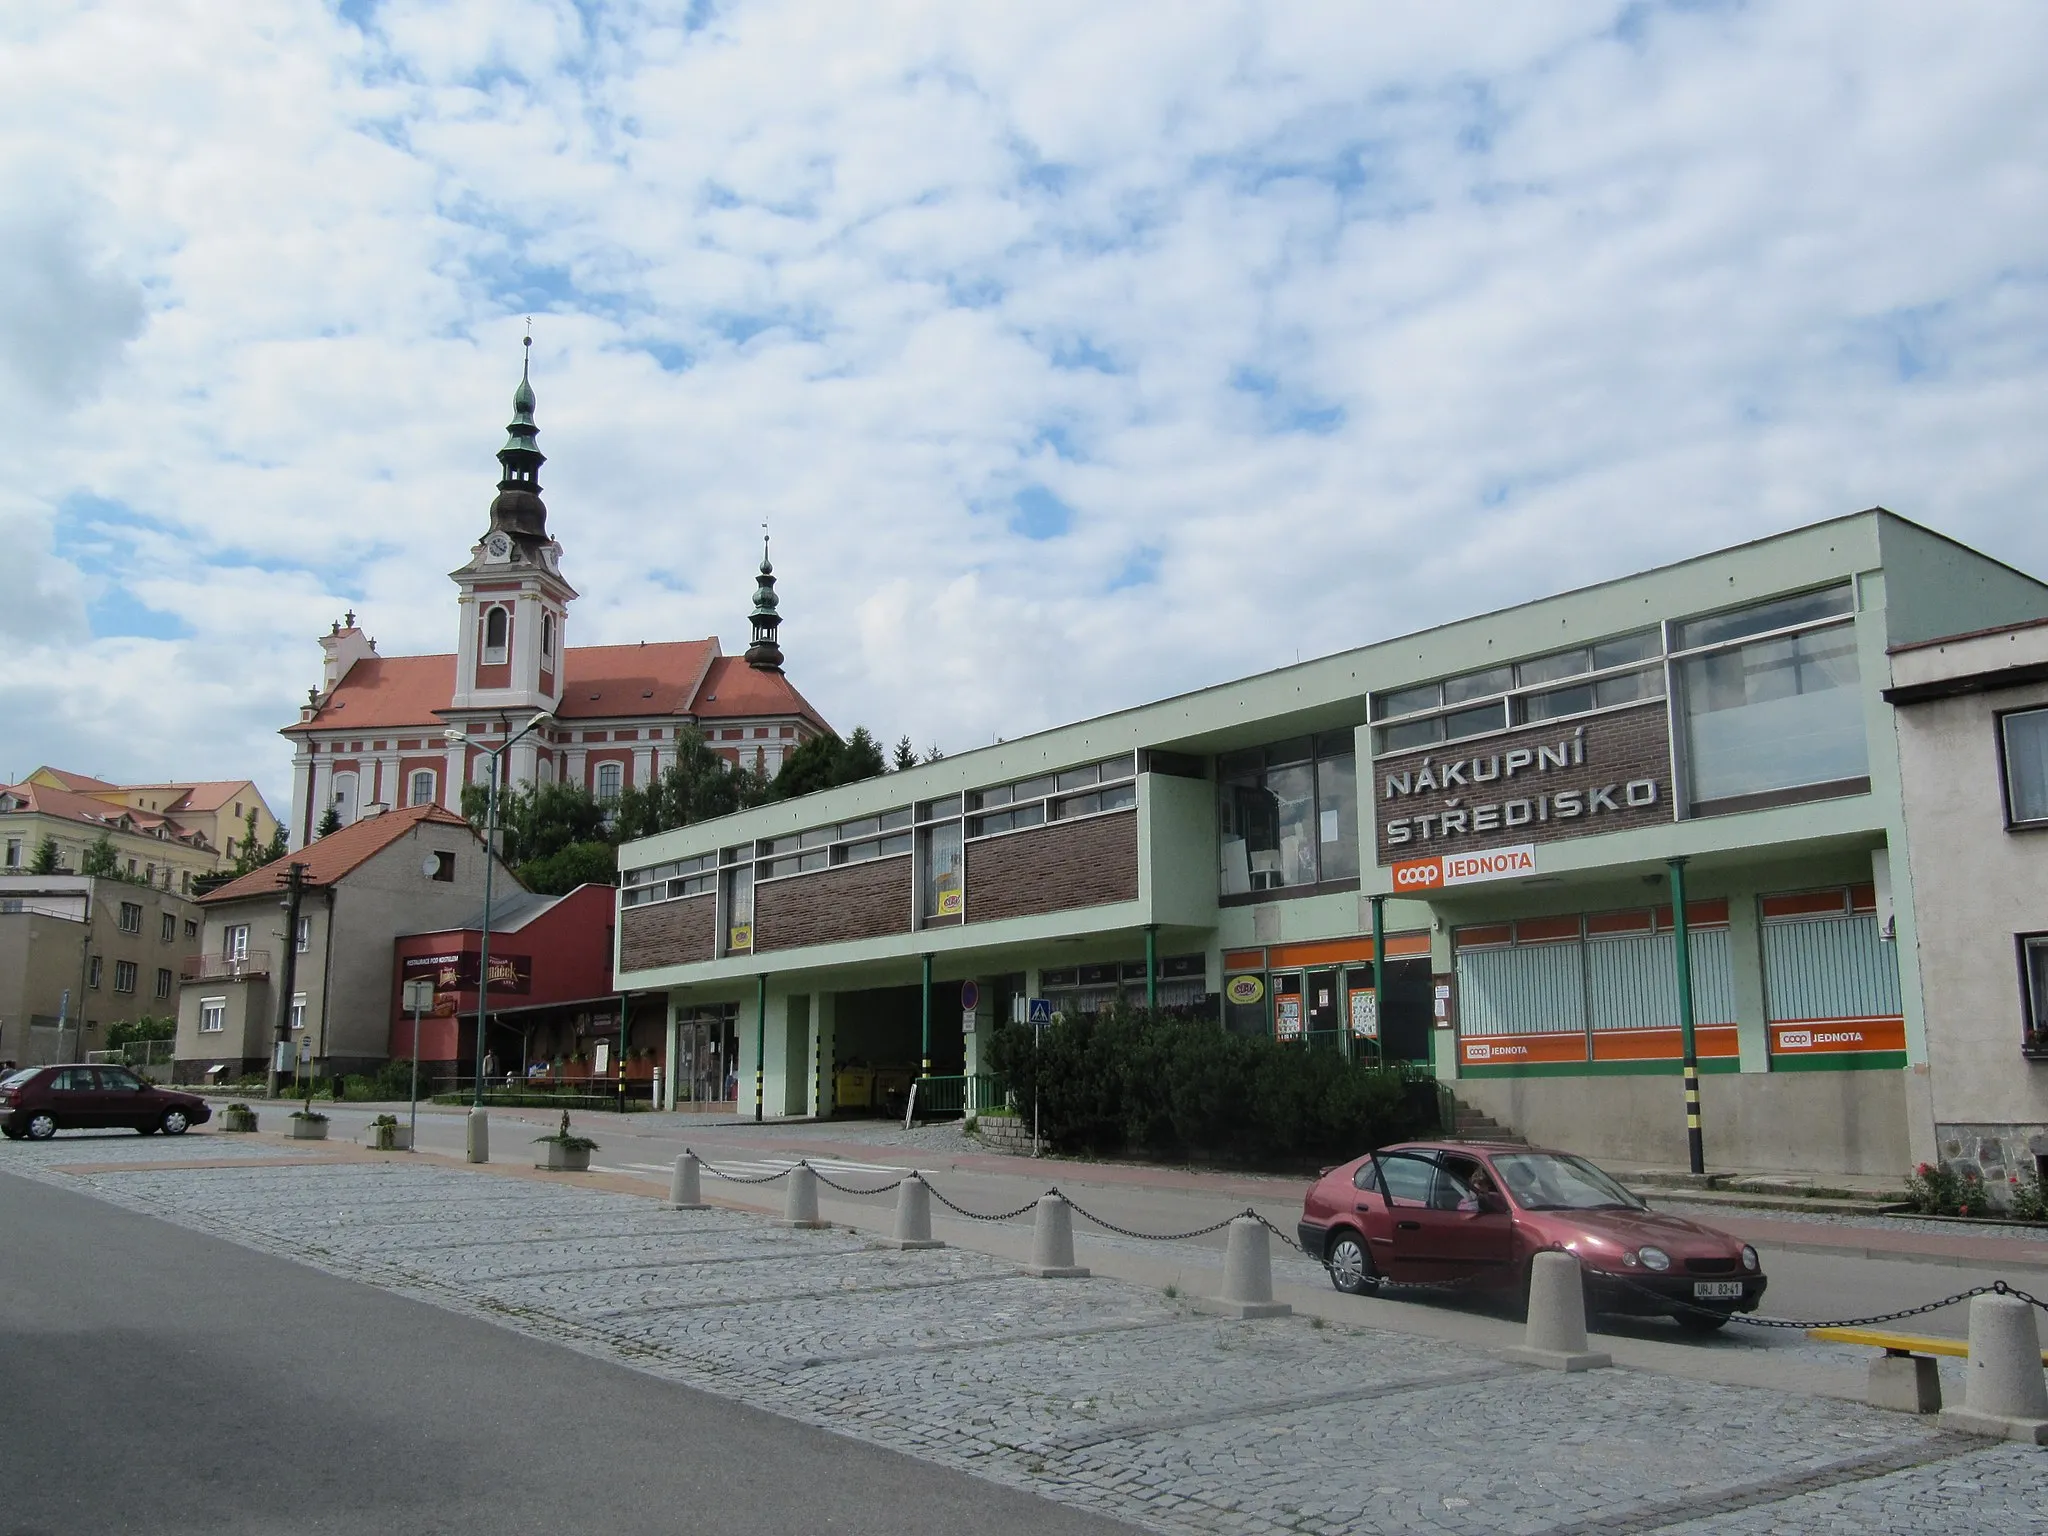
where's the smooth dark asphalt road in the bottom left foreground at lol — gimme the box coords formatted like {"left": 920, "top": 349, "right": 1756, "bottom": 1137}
{"left": 0, "top": 1176, "right": 1130, "bottom": 1536}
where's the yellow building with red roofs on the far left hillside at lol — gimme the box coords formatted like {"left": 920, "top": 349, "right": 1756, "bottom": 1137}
{"left": 0, "top": 768, "right": 276, "bottom": 895}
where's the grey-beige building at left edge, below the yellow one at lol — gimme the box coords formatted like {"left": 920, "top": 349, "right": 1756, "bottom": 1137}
{"left": 0, "top": 874, "right": 199, "bottom": 1065}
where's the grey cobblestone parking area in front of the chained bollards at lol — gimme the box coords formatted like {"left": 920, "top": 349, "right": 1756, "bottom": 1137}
{"left": 0, "top": 1135, "right": 2048, "bottom": 1536}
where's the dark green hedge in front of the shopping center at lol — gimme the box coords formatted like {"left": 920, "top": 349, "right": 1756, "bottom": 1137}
{"left": 991, "top": 1010, "right": 1438, "bottom": 1163}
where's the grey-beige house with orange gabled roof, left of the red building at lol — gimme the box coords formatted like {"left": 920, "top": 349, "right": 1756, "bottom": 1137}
{"left": 172, "top": 805, "right": 520, "bottom": 1083}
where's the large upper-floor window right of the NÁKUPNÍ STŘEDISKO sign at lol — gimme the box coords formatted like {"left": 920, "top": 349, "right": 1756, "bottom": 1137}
{"left": 1673, "top": 584, "right": 1870, "bottom": 813}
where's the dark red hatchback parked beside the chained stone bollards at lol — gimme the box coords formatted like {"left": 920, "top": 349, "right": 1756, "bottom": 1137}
{"left": 1300, "top": 1141, "right": 1767, "bottom": 1333}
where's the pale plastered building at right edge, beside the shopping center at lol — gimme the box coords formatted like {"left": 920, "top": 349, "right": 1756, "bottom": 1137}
{"left": 1884, "top": 623, "right": 2048, "bottom": 1184}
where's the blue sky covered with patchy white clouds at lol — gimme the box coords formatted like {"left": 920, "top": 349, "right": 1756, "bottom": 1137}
{"left": 0, "top": 0, "right": 2048, "bottom": 811}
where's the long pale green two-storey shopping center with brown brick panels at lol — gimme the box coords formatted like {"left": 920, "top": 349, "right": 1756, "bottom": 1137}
{"left": 616, "top": 510, "right": 2048, "bottom": 1174}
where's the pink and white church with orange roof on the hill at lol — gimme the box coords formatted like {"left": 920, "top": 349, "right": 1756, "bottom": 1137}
{"left": 283, "top": 346, "right": 831, "bottom": 848}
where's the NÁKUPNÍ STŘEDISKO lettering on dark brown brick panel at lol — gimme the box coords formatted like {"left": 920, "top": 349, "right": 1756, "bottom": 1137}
{"left": 1372, "top": 700, "right": 1673, "bottom": 866}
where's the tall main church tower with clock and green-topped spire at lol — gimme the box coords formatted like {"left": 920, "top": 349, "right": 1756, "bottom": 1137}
{"left": 446, "top": 336, "right": 575, "bottom": 729}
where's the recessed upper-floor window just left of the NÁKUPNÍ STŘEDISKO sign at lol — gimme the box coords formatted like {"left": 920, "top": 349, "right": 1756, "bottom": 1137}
{"left": 1217, "top": 731, "right": 1358, "bottom": 895}
